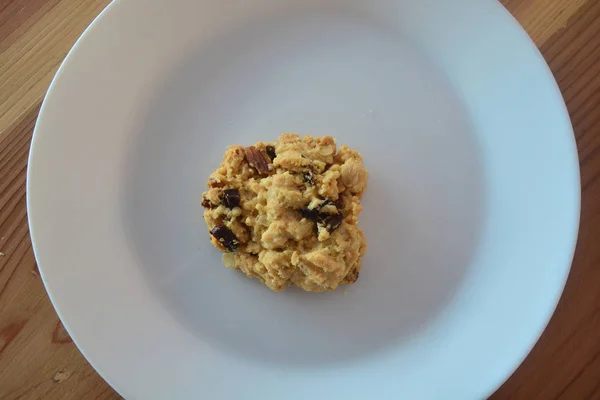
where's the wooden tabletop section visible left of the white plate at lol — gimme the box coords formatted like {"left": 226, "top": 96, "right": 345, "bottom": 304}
{"left": 0, "top": 0, "right": 120, "bottom": 400}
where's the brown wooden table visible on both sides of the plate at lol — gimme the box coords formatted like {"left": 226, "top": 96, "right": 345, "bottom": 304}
{"left": 0, "top": 0, "right": 600, "bottom": 400}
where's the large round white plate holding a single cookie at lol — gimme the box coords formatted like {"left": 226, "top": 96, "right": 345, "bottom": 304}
{"left": 28, "top": 0, "right": 580, "bottom": 400}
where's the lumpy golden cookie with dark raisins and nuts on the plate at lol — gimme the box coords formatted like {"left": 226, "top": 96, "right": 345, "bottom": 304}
{"left": 202, "top": 134, "right": 367, "bottom": 292}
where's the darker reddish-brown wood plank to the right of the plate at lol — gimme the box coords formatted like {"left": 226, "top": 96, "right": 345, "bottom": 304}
{"left": 493, "top": 0, "right": 600, "bottom": 399}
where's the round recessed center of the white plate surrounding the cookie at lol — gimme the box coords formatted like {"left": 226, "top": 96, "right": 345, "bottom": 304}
{"left": 123, "top": 13, "right": 483, "bottom": 366}
